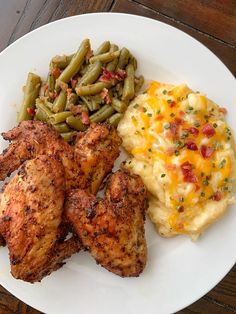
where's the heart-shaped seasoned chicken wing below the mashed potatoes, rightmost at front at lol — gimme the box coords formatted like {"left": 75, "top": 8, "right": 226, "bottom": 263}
{"left": 64, "top": 170, "right": 147, "bottom": 277}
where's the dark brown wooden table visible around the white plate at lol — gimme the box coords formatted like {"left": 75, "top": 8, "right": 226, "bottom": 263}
{"left": 0, "top": 0, "right": 236, "bottom": 314}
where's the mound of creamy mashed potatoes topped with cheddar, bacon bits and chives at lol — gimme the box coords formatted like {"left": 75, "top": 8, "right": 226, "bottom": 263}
{"left": 118, "top": 82, "right": 236, "bottom": 239}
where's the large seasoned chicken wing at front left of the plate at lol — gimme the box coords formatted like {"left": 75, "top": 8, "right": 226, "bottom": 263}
{"left": 0, "top": 155, "right": 80, "bottom": 282}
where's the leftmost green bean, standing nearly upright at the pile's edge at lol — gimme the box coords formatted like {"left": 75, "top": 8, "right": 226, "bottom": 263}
{"left": 18, "top": 72, "right": 41, "bottom": 122}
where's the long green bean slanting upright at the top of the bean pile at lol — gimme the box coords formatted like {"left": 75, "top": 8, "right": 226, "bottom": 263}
{"left": 56, "top": 39, "right": 90, "bottom": 88}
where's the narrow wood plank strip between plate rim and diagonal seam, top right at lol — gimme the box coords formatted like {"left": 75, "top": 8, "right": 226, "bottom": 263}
{"left": 112, "top": 0, "right": 236, "bottom": 76}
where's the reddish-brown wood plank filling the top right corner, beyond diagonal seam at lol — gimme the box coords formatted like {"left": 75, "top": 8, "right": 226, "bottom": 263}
{"left": 136, "top": 0, "right": 236, "bottom": 46}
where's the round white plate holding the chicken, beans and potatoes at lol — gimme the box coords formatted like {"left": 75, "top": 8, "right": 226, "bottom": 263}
{"left": 0, "top": 13, "right": 236, "bottom": 314}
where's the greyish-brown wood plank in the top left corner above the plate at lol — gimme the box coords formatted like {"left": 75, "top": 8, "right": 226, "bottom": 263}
{"left": 0, "top": 0, "right": 112, "bottom": 51}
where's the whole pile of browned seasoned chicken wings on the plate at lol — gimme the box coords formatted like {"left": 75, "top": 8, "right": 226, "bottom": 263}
{"left": 0, "top": 120, "right": 147, "bottom": 283}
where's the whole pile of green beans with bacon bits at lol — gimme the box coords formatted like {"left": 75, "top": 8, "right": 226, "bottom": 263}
{"left": 18, "top": 39, "right": 144, "bottom": 137}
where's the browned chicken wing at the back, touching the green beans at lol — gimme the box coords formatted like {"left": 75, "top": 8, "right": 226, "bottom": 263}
{"left": 0, "top": 121, "right": 121, "bottom": 194}
